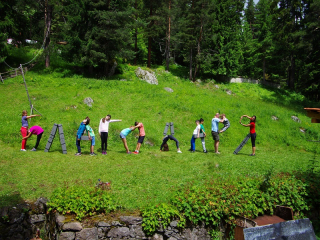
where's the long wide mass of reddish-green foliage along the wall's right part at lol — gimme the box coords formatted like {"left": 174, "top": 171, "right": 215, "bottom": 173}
{"left": 142, "top": 174, "right": 309, "bottom": 237}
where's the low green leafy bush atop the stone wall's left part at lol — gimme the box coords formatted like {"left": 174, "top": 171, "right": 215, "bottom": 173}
{"left": 48, "top": 187, "right": 117, "bottom": 220}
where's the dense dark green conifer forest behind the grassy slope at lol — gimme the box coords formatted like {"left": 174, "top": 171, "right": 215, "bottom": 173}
{"left": 0, "top": 0, "right": 320, "bottom": 101}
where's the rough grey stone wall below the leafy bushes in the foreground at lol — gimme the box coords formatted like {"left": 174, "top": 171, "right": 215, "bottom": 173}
{"left": 0, "top": 198, "right": 210, "bottom": 240}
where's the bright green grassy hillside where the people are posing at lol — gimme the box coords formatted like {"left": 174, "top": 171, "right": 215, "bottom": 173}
{"left": 0, "top": 65, "right": 320, "bottom": 209}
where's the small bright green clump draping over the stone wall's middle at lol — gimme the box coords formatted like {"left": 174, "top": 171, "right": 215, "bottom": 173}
{"left": 141, "top": 203, "right": 186, "bottom": 235}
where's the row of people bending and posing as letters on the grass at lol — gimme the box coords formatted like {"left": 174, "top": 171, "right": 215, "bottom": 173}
{"left": 20, "top": 110, "right": 256, "bottom": 156}
